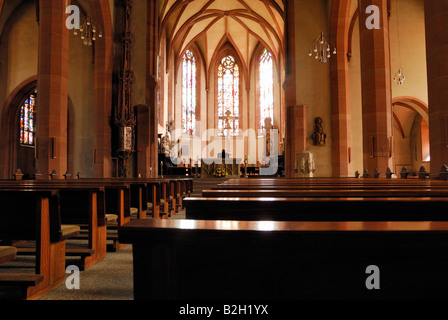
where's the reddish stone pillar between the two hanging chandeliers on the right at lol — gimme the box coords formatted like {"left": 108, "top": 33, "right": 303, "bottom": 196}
{"left": 359, "top": 0, "right": 394, "bottom": 176}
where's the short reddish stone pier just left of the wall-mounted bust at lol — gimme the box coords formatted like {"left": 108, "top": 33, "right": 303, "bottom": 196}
{"left": 285, "top": 105, "right": 306, "bottom": 177}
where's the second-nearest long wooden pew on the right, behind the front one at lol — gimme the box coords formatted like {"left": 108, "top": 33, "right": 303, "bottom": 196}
{"left": 184, "top": 197, "right": 448, "bottom": 221}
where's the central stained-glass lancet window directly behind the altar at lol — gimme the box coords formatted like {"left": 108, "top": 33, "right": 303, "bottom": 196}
{"left": 218, "top": 55, "right": 240, "bottom": 136}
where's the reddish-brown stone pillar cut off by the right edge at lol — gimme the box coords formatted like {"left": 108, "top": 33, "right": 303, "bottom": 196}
{"left": 425, "top": 0, "right": 448, "bottom": 176}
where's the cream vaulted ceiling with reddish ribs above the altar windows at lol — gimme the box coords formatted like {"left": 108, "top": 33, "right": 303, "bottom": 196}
{"left": 158, "top": 0, "right": 285, "bottom": 69}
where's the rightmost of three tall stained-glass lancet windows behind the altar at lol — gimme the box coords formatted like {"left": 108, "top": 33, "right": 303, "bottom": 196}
{"left": 259, "top": 49, "right": 274, "bottom": 129}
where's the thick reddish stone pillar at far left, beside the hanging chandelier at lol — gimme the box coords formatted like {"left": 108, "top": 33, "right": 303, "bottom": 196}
{"left": 36, "top": 0, "right": 69, "bottom": 179}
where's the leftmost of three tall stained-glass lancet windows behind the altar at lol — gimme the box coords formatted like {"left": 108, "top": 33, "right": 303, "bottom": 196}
{"left": 182, "top": 50, "right": 197, "bottom": 135}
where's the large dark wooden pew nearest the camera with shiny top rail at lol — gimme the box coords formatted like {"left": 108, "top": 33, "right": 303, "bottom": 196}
{"left": 119, "top": 220, "right": 448, "bottom": 298}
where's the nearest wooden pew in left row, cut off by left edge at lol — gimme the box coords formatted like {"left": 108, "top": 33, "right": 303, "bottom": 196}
{"left": 0, "top": 189, "right": 79, "bottom": 300}
